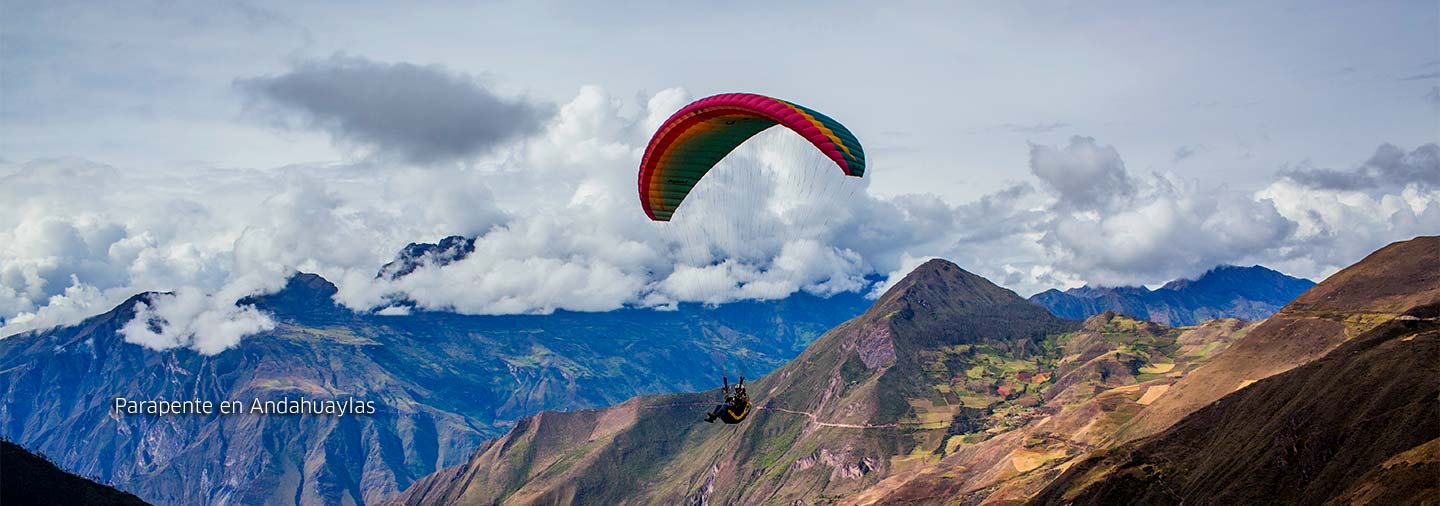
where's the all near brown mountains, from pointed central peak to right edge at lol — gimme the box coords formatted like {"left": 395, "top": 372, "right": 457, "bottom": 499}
{"left": 395, "top": 238, "right": 1440, "bottom": 505}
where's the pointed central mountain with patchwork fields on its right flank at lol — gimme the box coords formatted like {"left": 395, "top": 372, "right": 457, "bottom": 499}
{"left": 396, "top": 259, "right": 1250, "bottom": 505}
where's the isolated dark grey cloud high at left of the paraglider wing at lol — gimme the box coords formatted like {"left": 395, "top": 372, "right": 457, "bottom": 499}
{"left": 236, "top": 55, "right": 552, "bottom": 163}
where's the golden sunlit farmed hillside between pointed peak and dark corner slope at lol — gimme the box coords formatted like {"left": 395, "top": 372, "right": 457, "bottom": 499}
{"left": 842, "top": 313, "right": 1254, "bottom": 505}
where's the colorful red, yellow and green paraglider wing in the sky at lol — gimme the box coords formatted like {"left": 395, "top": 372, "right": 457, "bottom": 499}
{"left": 639, "top": 94, "right": 865, "bottom": 222}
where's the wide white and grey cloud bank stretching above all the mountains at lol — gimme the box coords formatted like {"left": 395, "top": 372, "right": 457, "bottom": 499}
{"left": 0, "top": 58, "right": 1440, "bottom": 353}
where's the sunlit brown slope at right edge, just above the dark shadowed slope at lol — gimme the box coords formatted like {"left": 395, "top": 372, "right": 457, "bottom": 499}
{"left": 1117, "top": 236, "right": 1440, "bottom": 441}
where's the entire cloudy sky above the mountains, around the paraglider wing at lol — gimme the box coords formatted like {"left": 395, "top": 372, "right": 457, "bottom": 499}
{"left": 0, "top": 0, "right": 1440, "bottom": 353}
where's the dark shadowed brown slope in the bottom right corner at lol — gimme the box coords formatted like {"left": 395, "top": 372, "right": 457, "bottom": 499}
{"left": 1035, "top": 302, "right": 1440, "bottom": 505}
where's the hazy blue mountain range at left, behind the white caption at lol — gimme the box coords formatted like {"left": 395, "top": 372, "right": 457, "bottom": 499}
{"left": 0, "top": 274, "right": 868, "bottom": 505}
